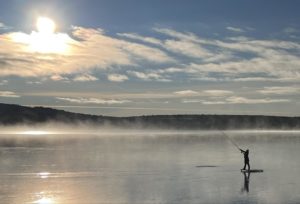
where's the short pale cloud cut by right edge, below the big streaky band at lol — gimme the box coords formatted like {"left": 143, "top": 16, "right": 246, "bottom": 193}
{"left": 257, "top": 86, "right": 300, "bottom": 95}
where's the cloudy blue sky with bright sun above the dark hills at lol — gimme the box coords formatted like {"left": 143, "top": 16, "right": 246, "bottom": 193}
{"left": 0, "top": 0, "right": 300, "bottom": 116}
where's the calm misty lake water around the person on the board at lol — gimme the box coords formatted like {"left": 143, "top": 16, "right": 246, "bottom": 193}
{"left": 0, "top": 132, "right": 300, "bottom": 204}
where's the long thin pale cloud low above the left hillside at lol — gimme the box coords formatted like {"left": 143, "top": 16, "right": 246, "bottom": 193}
{"left": 56, "top": 97, "right": 131, "bottom": 105}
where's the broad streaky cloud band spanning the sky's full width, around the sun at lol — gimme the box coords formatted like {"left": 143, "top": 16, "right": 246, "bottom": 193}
{"left": 0, "top": 24, "right": 300, "bottom": 82}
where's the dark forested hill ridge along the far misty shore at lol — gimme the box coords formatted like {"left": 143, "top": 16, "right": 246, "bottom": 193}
{"left": 0, "top": 103, "right": 300, "bottom": 130}
